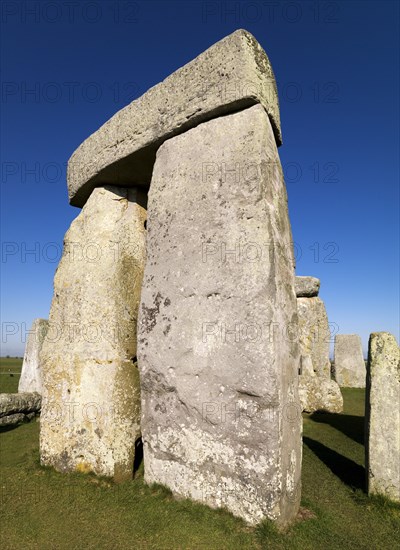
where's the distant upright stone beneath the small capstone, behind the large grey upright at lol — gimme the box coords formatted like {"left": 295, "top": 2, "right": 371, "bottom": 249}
{"left": 297, "top": 297, "right": 331, "bottom": 379}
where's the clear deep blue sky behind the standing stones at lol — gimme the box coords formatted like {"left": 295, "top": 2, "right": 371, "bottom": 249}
{"left": 0, "top": 0, "right": 399, "bottom": 355}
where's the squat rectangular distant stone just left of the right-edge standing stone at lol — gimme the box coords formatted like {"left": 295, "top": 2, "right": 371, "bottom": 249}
{"left": 335, "top": 334, "right": 366, "bottom": 388}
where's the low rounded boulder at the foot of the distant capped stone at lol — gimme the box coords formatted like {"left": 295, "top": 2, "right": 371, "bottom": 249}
{"left": 299, "top": 355, "right": 343, "bottom": 413}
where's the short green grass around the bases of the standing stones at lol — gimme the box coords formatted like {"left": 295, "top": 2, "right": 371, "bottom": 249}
{"left": 0, "top": 364, "right": 400, "bottom": 550}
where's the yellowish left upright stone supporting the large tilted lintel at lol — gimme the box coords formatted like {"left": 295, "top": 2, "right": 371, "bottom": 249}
{"left": 40, "top": 187, "right": 146, "bottom": 481}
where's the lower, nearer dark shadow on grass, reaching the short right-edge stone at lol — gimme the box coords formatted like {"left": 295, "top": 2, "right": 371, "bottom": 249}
{"left": 303, "top": 437, "right": 366, "bottom": 491}
